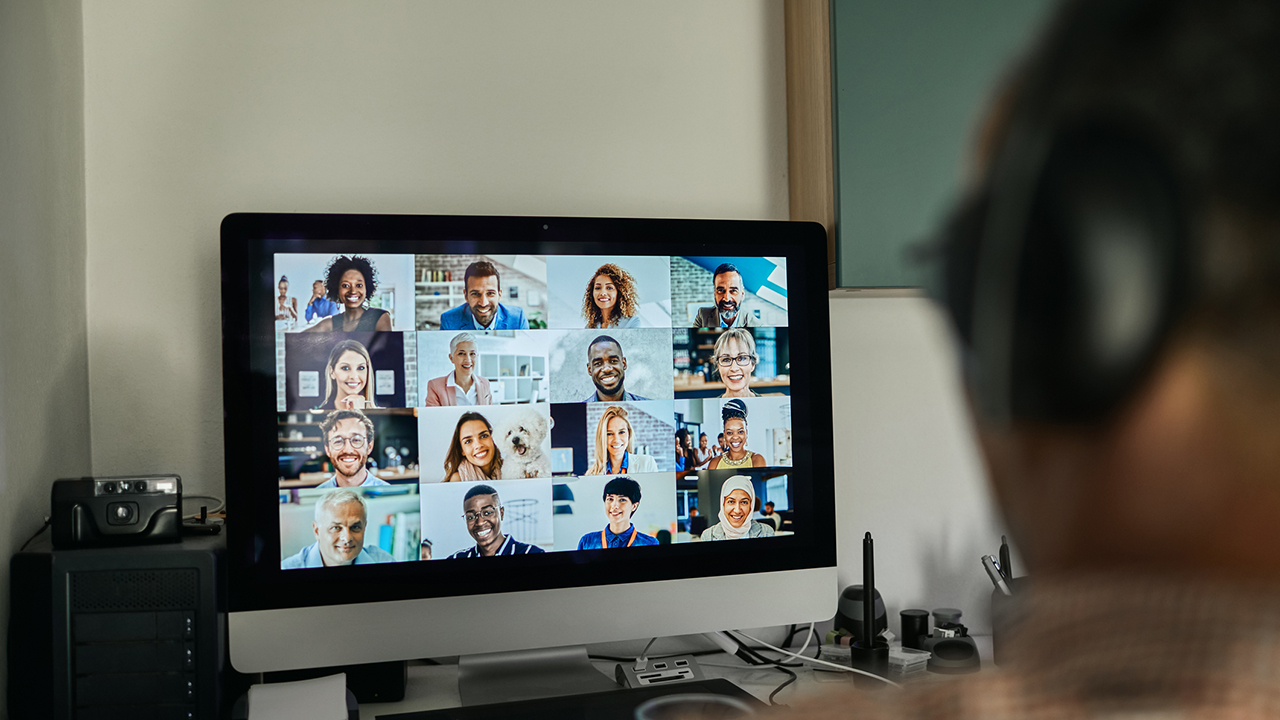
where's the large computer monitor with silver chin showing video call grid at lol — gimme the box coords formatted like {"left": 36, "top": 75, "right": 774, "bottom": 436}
{"left": 221, "top": 214, "right": 837, "bottom": 673}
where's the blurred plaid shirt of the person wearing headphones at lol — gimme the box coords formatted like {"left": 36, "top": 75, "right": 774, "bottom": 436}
{"left": 787, "top": 577, "right": 1280, "bottom": 720}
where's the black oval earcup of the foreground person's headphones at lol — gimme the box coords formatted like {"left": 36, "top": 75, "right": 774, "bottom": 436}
{"left": 1008, "top": 127, "right": 1189, "bottom": 423}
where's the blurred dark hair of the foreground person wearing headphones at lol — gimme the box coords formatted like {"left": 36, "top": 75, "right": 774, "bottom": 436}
{"left": 1003, "top": 0, "right": 1280, "bottom": 368}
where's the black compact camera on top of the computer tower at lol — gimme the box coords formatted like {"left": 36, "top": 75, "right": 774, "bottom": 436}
{"left": 50, "top": 475, "right": 182, "bottom": 548}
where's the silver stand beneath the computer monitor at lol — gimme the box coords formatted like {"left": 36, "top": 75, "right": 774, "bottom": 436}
{"left": 458, "top": 646, "right": 618, "bottom": 705}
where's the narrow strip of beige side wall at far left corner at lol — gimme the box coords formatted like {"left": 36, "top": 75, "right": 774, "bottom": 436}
{"left": 0, "top": 0, "right": 90, "bottom": 716}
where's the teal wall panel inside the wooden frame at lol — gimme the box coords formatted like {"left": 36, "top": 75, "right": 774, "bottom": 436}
{"left": 832, "top": 0, "right": 1055, "bottom": 287}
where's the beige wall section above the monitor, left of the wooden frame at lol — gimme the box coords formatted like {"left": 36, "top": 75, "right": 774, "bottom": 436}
{"left": 84, "top": 0, "right": 787, "bottom": 493}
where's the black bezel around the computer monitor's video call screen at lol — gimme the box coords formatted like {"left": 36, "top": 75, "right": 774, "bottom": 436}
{"left": 221, "top": 213, "right": 836, "bottom": 611}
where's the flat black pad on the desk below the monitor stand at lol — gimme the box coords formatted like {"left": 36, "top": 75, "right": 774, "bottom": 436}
{"left": 378, "top": 678, "right": 765, "bottom": 720}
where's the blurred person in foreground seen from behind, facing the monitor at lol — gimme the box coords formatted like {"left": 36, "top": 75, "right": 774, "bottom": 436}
{"left": 788, "top": 0, "right": 1280, "bottom": 720}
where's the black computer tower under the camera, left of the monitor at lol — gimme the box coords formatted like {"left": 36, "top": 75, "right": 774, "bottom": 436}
{"left": 8, "top": 536, "right": 227, "bottom": 720}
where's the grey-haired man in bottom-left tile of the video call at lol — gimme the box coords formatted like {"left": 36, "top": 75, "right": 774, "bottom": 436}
{"left": 280, "top": 488, "right": 394, "bottom": 570}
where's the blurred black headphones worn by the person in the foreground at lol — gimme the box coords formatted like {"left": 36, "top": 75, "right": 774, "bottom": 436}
{"left": 933, "top": 0, "right": 1192, "bottom": 424}
